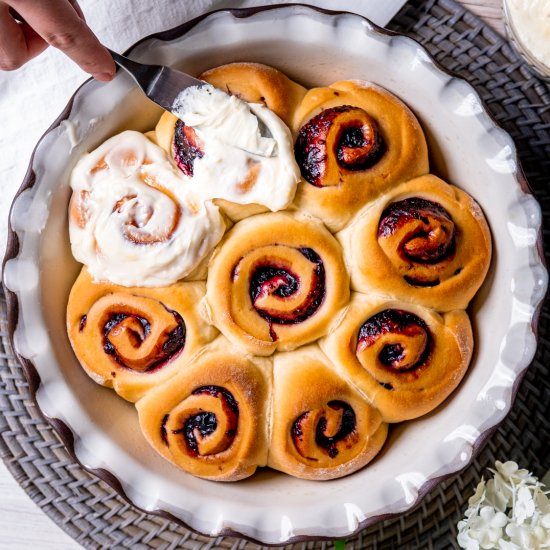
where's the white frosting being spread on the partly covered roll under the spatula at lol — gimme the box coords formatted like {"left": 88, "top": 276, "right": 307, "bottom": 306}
{"left": 172, "top": 84, "right": 300, "bottom": 211}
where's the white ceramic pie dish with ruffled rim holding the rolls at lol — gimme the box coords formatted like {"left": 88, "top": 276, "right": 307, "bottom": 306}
{"left": 4, "top": 6, "right": 547, "bottom": 544}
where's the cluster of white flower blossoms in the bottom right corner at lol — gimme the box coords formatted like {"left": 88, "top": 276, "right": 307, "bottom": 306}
{"left": 457, "top": 461, "right": 550, "bottom": 550}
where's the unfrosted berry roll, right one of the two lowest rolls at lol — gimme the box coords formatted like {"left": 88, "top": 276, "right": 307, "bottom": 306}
{"left": 268, "top": 346, "right": 388, "bottom": 480}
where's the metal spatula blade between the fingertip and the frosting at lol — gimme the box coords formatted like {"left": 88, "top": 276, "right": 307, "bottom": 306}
{"left": 109, "top": 50, "right": 205, "bottom": 111}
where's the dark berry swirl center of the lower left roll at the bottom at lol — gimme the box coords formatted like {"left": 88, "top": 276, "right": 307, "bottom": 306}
{"left": 165, "top": 385, "right": 239, "bottom": 458}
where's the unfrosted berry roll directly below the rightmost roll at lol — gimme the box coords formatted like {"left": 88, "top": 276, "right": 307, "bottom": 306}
{"left": 321, "top": 294, "right": 473, "bottom": 422}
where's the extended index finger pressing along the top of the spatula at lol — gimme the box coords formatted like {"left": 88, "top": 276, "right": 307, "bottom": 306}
{"left": 6, "top": 0, "right": 115, "bottom": 80}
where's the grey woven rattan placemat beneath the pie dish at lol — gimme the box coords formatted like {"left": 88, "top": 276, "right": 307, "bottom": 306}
{"left": 0, "top": 0, "right": 550, "bottom": 550}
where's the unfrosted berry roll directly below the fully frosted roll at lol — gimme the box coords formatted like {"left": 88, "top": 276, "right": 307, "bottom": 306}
{"left": 67, "top": 267, "right": 217, "bottom": 401}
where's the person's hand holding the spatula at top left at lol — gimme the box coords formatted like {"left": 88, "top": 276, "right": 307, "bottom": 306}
{"left": 0, "top": 0, "right": 115, "bottom": 81}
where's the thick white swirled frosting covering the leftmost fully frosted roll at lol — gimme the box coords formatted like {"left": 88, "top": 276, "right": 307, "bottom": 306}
{"left": 69, "top": 131, "right": 225, "bottom": 287}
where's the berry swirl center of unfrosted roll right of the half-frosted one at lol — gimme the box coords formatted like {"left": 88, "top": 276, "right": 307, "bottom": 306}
{"left": 294, "top": 105, "right": 385, "bottom": 187}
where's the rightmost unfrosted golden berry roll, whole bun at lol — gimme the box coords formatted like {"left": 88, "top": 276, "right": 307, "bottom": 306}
{"left": 338, "top": 175, "right": 491, "bottom": 311}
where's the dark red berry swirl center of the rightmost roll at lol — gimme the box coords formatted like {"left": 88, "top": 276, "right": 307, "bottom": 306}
{"left": 378, "top": 197, "right": 461, "bottom": 287}
